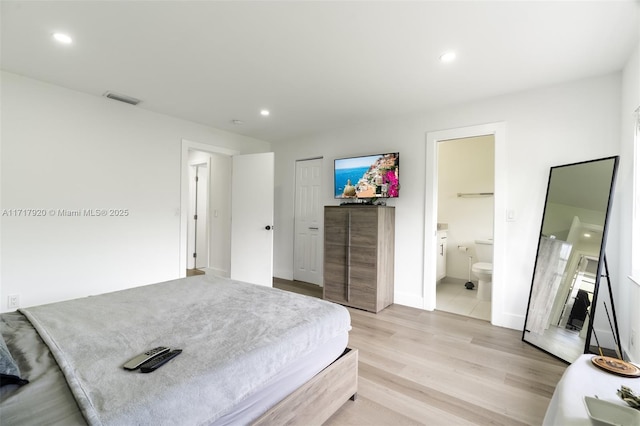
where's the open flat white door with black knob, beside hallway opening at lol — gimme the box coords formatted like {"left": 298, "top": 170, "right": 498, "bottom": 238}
{"left": 231, "top": 152, "right": 274, "bottom": 287}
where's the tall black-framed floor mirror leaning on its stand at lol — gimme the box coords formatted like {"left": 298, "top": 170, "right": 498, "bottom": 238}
{"left": 522, "top": 156, "right": 618, "bottom": 363}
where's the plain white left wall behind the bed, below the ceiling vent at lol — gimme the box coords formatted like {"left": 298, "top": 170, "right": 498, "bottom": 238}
{"left": 0, "top": 72, "right": 270, "bottom": 311}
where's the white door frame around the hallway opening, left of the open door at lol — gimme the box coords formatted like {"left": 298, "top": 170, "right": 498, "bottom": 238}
{"left": 176, "top": 139, "right": 240, "bottom": 278}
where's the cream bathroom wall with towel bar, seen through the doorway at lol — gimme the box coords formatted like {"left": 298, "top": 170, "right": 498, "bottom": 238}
{"left": 438, "top": 135, "right": 494, "bottom": 280}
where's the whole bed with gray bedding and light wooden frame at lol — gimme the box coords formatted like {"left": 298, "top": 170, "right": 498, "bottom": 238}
{"left": 0, "top": 275, "right": 357, "bottom": 426}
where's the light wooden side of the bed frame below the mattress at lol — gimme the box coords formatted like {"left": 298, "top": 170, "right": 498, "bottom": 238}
{"left": 253, "top": 348, "right": 358, "bottom": 426}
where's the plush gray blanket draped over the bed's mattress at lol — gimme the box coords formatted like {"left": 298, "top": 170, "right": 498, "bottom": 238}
{"left": 21, "top": 276, "right": 350, "bottom": 425}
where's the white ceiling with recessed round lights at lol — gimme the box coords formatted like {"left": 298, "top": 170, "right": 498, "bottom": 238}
{"left": 0, "top": 0, "right": 640, "bottom": 142}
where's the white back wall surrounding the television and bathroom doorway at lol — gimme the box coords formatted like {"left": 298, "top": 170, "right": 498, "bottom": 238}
{"left": 274, "top": 73, "right": 621, "bottom": 328}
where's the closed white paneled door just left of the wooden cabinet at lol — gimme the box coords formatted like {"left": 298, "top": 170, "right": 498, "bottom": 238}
{"left": 293, "top": 158, "right": 323, "bottom": 285}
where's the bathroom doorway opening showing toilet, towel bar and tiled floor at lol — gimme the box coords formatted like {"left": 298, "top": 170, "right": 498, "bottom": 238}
{"left": 436, "top": 134, "right": 495, "bottom": 321}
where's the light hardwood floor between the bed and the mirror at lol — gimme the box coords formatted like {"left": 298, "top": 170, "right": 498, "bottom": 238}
{"left": 276, "top": 284, "right": 567, "bottom": 426}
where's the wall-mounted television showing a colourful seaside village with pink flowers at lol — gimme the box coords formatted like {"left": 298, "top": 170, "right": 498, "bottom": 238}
{"left": 333, "top": 152, "right": 400, "bottom": 199}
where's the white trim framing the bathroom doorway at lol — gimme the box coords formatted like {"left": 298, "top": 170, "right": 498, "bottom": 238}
{"left": 422, "top": 122, "right": 508, "bottom": 328}
